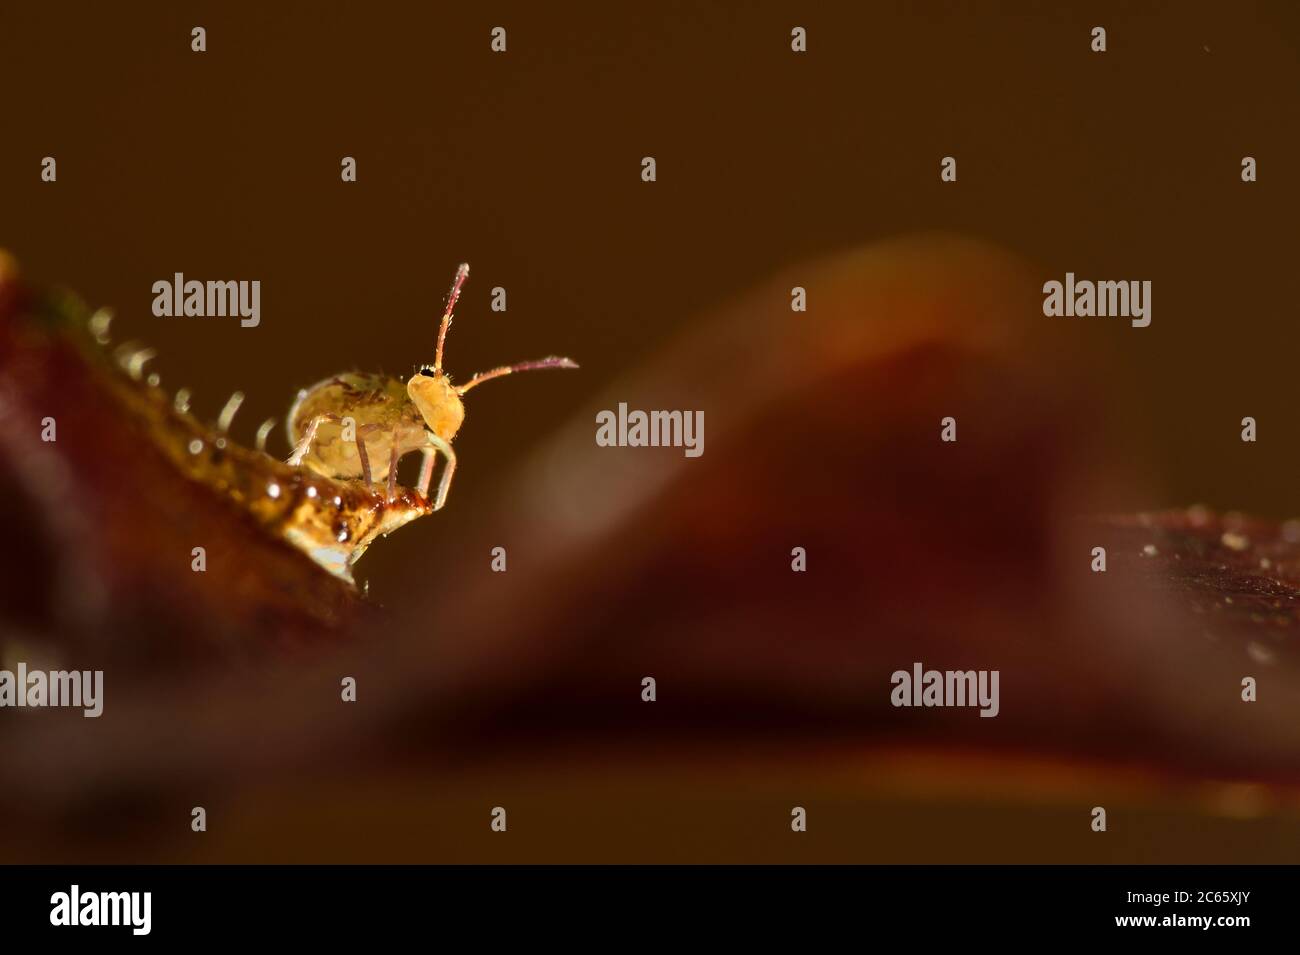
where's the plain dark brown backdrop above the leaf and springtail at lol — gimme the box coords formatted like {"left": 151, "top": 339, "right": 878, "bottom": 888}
{"left": 0, "top": 3, "right": 1300, "bottom": 858}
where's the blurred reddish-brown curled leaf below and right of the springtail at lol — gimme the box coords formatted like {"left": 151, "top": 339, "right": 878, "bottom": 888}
{"left": 0, "top": 236, "right": 1300, "bottom": 861}
